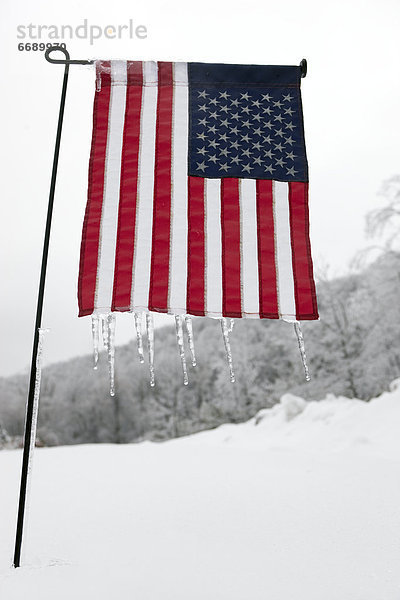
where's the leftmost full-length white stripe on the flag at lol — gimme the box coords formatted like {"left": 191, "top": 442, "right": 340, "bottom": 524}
{"left": 95, "top": 60, "right": 127, "bottom": 312}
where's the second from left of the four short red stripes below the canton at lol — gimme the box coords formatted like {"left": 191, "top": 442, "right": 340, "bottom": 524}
{"left": 221, "top": 177, "right": 242, "bottom": 317}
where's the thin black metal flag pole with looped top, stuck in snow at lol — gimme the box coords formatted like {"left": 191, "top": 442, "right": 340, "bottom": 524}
{"left": 13, "top": 50, "right": 307, "bottom": 568}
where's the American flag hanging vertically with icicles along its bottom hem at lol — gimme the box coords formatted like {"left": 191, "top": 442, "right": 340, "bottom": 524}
{"left": 78, "top": 60, "right": 318, "bottom": 321}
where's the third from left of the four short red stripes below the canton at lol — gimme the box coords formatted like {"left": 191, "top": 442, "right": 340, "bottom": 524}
{"left": 256, "top": 179, "right": 279, "bottom": 319}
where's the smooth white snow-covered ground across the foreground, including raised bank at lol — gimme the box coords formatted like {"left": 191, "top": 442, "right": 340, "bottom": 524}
{"left": 0, "top": 385, "right": 400, "bottom": 600}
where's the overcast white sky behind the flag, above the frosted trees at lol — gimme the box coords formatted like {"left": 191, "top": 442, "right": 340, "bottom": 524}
{"left": 0, "top": 0, "right": 400, "bottom": 375}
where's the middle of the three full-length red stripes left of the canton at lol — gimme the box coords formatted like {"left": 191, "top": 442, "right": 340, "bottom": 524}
{"left": 112, "top": 61, "right": 143, "bottom": 311}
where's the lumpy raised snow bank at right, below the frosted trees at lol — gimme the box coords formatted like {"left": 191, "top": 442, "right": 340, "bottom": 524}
{"left": 185, "top": 379, "right": 400, "bottom": 460}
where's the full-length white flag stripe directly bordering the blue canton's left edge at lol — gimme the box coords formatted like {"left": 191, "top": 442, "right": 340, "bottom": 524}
{"left": 168, "top": 62, "right": 189, "bottom": 314}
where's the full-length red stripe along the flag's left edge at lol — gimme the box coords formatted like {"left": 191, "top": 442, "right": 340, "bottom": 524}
{"left": 78, "top": 62, "right": 111, "bottom": 317}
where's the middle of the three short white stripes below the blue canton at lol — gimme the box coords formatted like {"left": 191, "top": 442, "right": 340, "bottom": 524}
{"left": 239, "top": 179, "right": 260, "bottom": 319}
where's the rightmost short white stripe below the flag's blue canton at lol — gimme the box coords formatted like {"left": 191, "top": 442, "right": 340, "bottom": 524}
{"left": 273, "top": 181, "right": 296, "bottom": 321}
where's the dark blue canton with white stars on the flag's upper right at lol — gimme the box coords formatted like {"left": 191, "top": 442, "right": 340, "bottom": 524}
{"left": 188, "top": 63, "right": 308, "bottom": 181}
